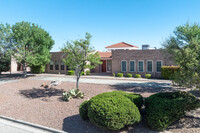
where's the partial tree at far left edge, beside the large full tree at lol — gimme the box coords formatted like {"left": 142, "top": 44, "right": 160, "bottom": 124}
{"left": 0, "top": 24, "right": 12, "bottom": 74}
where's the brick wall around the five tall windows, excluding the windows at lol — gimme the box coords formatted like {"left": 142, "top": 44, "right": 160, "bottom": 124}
{"left": 112, "top": 49, "right": 175, "bottom": 78}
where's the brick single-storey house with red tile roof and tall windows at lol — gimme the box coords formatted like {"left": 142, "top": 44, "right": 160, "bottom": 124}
{"left": 11, "top": 42, "right": 175, "bottom": 78}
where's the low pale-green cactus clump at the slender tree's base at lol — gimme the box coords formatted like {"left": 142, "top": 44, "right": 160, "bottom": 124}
{"left": 62, "top": 89, "right": 85, "bottom": 101}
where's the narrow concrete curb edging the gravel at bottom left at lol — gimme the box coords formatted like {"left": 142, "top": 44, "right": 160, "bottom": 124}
{"left": 0, "top": 116, "right": 67, "bottom": 133}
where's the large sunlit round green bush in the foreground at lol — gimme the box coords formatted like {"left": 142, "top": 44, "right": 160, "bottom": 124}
{"left": 88, "top": 92, "right": 141, "bottom": 130}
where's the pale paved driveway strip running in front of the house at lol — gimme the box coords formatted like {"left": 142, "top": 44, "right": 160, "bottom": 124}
{"left": 31, "top": 76, "right": 171, "bottom": 88}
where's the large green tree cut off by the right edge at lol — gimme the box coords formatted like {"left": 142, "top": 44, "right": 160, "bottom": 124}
{"left": 163, "top": 23, "right": 200, "bottom": 88}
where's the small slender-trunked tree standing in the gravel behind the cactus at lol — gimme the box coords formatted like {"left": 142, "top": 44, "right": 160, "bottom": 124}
{"left": 62, "top": 33, "right": 101, "bottom": 89}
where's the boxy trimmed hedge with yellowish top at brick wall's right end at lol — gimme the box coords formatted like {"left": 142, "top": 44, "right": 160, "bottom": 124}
{"left": 161, "top": 66, "right": 180, "bottom": 79}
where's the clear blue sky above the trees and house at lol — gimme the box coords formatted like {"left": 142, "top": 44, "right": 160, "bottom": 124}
{"left": 0, "top": 0, "right": 200, "bottom": 51}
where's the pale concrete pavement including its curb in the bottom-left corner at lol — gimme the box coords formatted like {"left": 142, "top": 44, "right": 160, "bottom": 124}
{"left": 0, "top": 116, "right": 66, "bottom": 133}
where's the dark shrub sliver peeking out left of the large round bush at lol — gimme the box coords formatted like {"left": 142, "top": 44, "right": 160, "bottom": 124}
{"left": 79, "top": 101, "right": 89, "bottom": 120}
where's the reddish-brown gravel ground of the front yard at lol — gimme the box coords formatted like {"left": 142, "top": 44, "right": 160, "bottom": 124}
{"left": 0, "top": 78, "right": 200, "bottom": 133}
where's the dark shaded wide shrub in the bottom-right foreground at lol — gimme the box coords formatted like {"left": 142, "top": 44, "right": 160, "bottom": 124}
{"left": 145, "top": 91, "right": 200, "bottom": 131}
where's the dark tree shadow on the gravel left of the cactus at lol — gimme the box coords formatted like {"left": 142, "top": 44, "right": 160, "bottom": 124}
{"left": 20, "top": 88, "right": 64, "bottom": 98}
